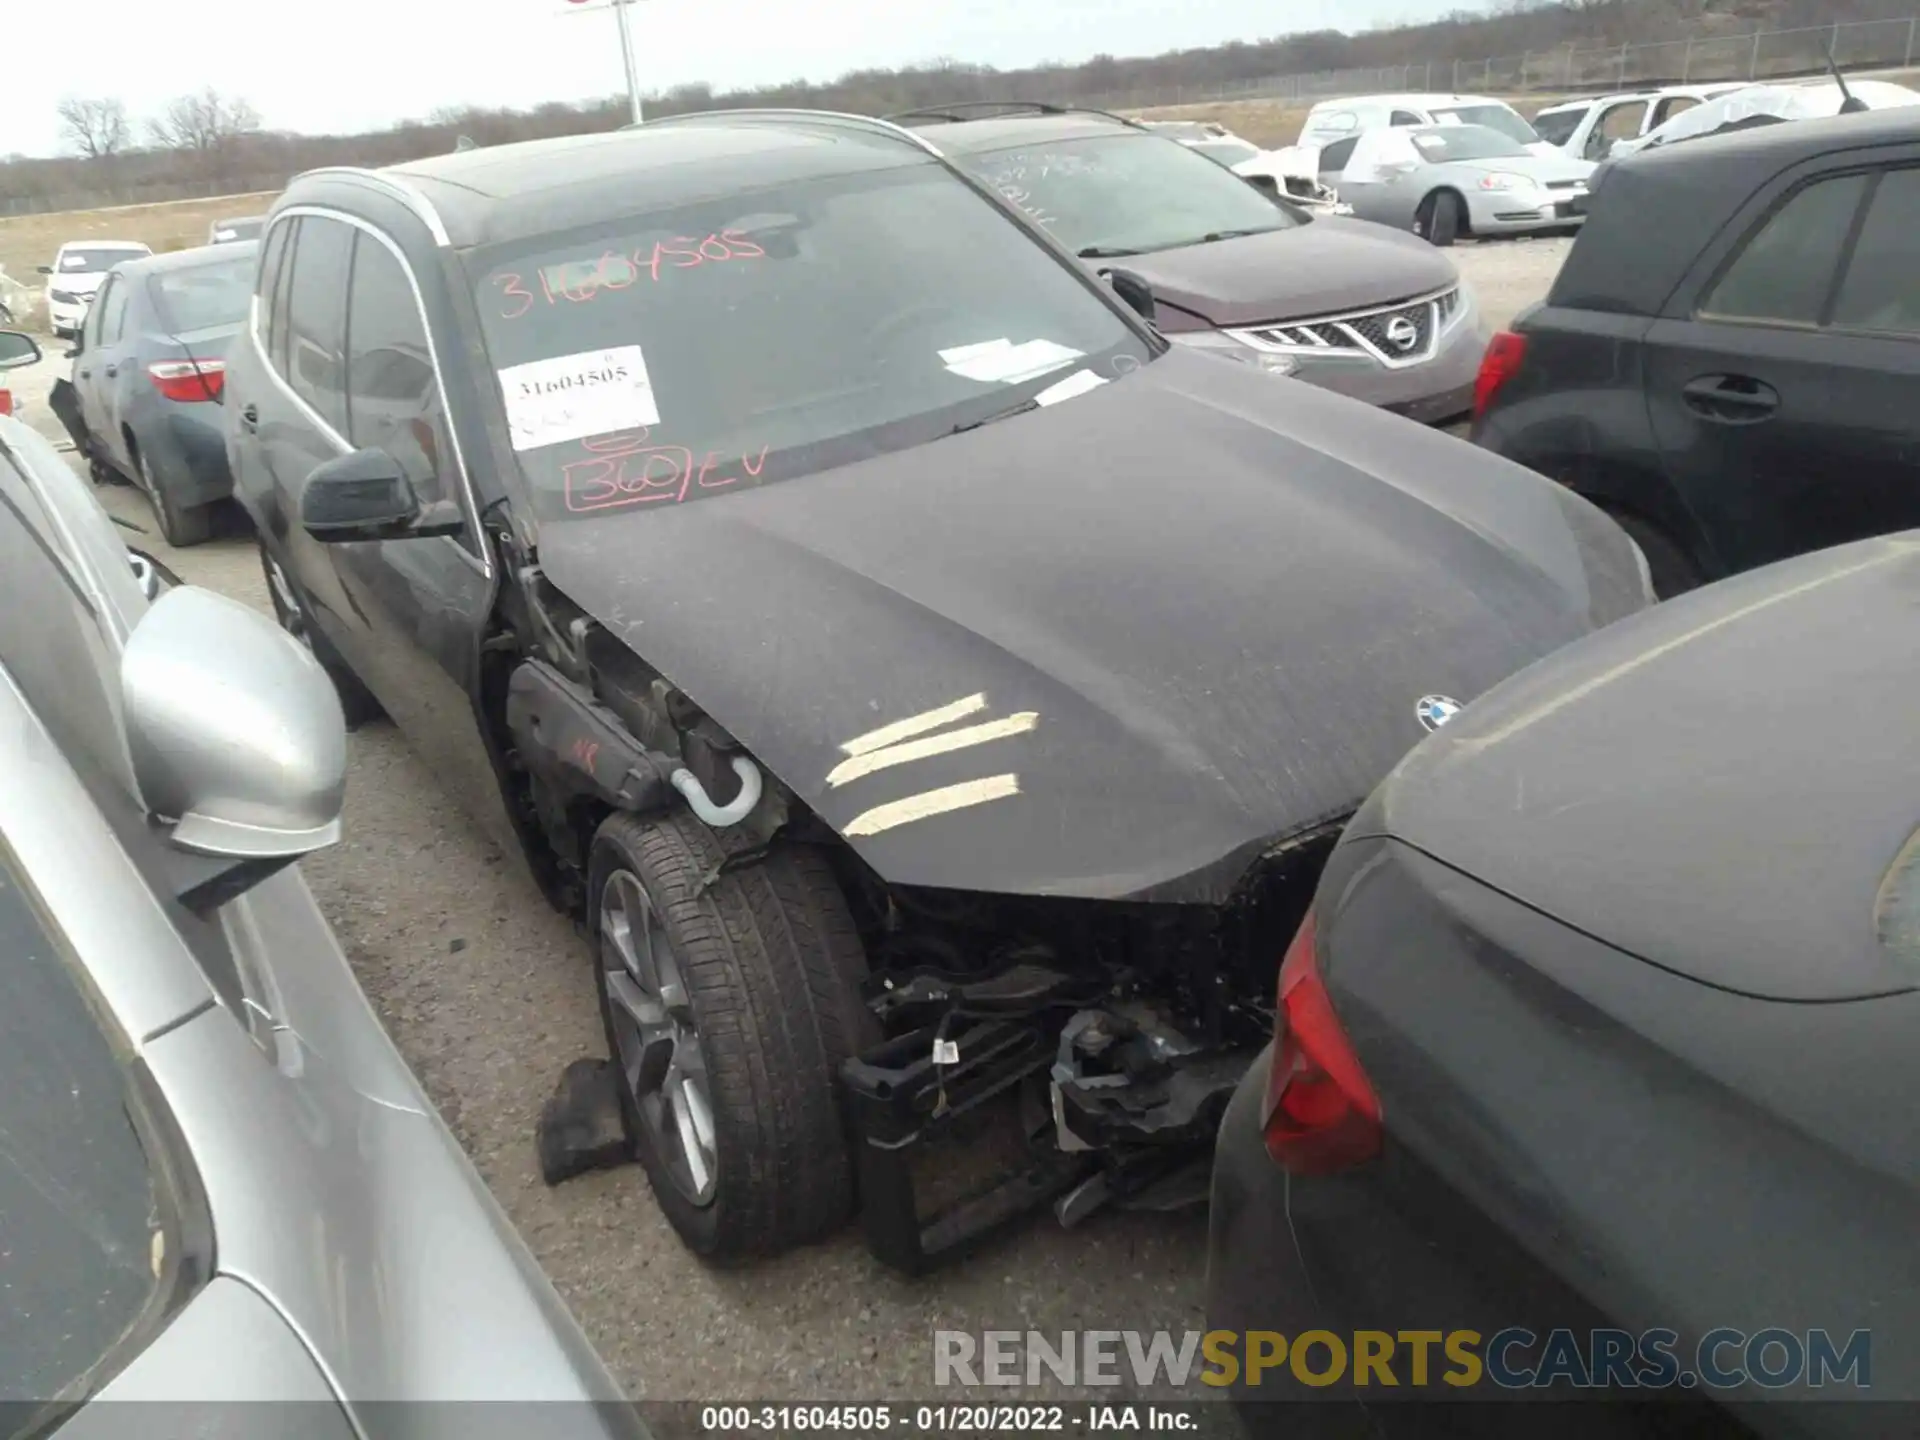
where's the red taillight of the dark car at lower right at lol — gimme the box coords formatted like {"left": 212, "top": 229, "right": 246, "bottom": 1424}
{"left": 1265, "top": 914, "right": 1380, "bottom": 1175}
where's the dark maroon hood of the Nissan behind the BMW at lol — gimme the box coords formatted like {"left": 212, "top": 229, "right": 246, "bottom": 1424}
{"left": 1102, "top": 217, "right": 1459, "bottom": 332}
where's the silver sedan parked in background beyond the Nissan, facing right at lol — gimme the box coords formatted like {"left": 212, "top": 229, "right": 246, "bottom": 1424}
{"left": 1319, "top": 125, "right": 1594, "bottom": 246}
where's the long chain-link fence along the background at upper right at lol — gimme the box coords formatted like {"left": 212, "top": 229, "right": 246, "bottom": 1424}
{"left": 1077, "top": 17, "right": 1920, "bottom": 109}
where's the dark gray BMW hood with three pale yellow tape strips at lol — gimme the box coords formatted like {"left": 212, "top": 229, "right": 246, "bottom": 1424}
{"left": 538, "top": 351, "right": 1644, "bottom": 900}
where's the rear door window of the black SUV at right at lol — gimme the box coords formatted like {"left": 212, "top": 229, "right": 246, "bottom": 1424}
{"left": 1699, "top": 175, "right": 1868, "bottom": 324}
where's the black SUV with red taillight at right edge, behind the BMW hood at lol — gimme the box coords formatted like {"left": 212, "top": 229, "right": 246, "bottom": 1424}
{"left": 1473, "top": 109, "right": 1920, "bottom": 595}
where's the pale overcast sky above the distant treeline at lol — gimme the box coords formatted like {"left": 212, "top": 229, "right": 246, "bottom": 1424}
{"left": 18, "top": 0, "right": 1459, "bottom": 154}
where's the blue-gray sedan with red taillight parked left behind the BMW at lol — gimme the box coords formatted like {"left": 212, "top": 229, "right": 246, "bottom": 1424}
{"left": 56, "top": 240, "right": 259, "bottom": 547}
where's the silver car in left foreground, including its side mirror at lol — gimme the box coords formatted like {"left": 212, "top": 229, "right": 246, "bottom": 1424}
{"left": 0, "top": 334, "right": 641, "bottom": 1440}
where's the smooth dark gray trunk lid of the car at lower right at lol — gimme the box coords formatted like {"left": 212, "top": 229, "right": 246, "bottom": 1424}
{"left": 1354, "top": 532, "right": 1920, "bottom": 1000}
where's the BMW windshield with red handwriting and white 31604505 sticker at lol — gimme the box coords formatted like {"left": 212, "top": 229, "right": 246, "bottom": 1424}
{"left": 467, "top": 163, "right": 1144, "bottom": 518}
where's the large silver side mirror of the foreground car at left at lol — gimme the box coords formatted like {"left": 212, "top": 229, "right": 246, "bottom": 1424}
{"left": 121, "top": 586, "right": 348, "bottom": 912}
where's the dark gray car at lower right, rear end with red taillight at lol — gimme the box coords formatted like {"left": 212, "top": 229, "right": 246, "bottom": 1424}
{"left": 1208, "top": 532, "right": 1920, "bottom": 1436}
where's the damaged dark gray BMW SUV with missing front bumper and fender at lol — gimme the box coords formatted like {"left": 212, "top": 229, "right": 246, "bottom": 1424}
{"left": 227, "top": 111, "right": 1649, "bottom": 1269}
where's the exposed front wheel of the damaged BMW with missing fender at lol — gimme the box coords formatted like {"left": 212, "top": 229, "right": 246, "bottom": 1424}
{"left": 588, "top": 812, "right": 877, "bottom": 1260}
